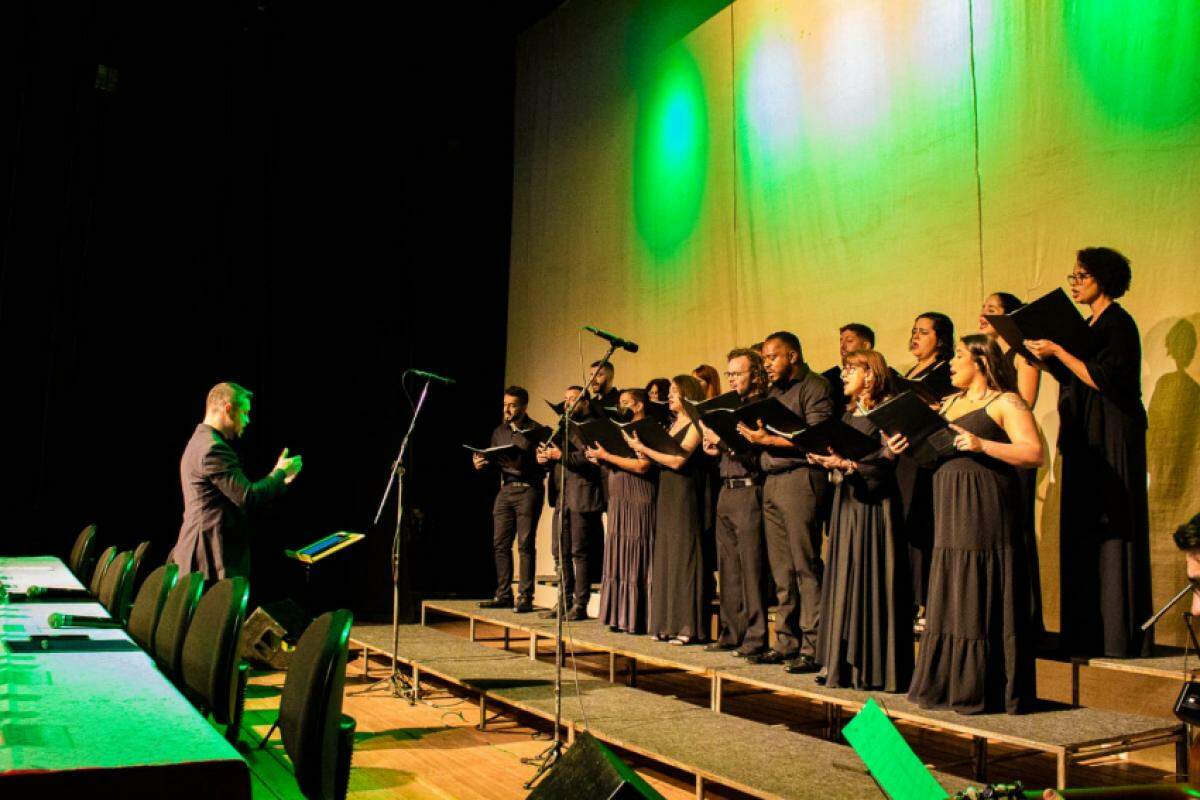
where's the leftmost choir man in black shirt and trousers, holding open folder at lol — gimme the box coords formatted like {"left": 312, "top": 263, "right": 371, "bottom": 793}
{"left": 472, "top": 386, "right": 546, "bottom": 614}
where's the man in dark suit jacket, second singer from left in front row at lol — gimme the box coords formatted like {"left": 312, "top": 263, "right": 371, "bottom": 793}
{"left": 538, "top": 386, "right": 605, "bottom": 620}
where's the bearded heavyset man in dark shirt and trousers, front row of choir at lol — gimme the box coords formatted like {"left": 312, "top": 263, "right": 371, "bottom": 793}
{"left": 739, "top": 331, "right": 833, "bottom": 672}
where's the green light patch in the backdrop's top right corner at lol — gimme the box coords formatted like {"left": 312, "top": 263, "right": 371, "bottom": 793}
{"left": 1063, "top": 0, "right": 1200, "bottom": 130}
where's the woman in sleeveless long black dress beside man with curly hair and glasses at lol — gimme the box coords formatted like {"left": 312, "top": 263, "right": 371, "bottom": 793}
{"left": 629, "top": 375, "right": 708, "bottom": 644}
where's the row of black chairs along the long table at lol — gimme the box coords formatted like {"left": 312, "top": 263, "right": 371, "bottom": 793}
{"left": 68, "top": 525, "right": 356, "bottom": 800}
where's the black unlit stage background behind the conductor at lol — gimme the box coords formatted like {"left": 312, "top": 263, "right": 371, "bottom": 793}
{"left": 0, "top": 0, "right": 556, "bottom": 615}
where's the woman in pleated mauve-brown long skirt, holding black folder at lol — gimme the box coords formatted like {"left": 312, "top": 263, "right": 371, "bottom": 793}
{"left": 587, "top": 389, "right": 654, "bottom": 633}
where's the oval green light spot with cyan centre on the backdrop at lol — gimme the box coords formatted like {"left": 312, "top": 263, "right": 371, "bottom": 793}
{"left": 634, "top": 44, "right": 708, "bottom": 258}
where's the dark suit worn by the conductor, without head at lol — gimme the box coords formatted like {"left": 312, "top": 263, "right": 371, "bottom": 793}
{"left": 172, "top": 422, "right": 286, "bottom": 581}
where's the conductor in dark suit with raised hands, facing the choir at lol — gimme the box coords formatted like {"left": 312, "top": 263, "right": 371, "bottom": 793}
{"left": 172, "top": 383, "right": 304, "bottom": 581}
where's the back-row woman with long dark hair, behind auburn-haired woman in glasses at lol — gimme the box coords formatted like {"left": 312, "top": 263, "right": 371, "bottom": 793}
{"left": 896, "top": 311, "right": 954, "bottom": 626}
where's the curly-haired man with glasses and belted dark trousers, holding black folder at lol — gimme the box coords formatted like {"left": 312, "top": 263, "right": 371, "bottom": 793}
{"left": 701, "top": 348, "right": 767, "bottom": 658}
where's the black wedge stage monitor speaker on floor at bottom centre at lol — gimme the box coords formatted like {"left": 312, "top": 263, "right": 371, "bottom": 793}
{"left": 528, "top": 733, "right": 662, "bottom": 800}
